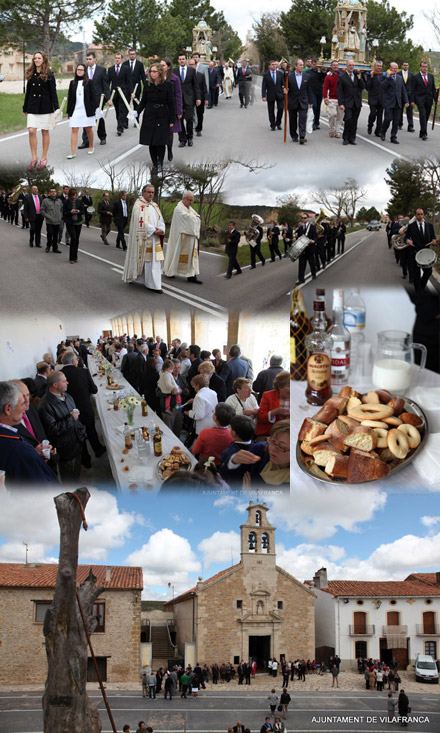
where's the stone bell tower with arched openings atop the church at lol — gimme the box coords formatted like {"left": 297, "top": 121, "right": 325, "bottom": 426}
{"left": 240, "top": 501, "right": 276, "bottom": 570}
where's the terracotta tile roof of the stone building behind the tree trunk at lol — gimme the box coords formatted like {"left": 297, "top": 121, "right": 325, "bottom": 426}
{"left": 0, "top": 563, "right": 143, "bottom": 590}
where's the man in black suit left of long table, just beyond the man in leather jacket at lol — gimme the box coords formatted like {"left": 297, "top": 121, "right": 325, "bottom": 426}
{"left": 62, "top": 351, "right": 107, "bottom": 458}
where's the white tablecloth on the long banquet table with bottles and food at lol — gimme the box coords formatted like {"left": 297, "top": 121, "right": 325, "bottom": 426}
{"left": 88, "top": 357, "right": 196, "bottom": 491}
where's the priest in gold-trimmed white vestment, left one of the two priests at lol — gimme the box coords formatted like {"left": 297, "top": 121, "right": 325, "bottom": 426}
{"left": 122, "top": 185, "right": 165, "bottom": 293}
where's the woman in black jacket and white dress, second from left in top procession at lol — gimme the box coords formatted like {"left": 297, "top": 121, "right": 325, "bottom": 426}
{"left": 67, "top": 64, "right": 98, "bottom": 160}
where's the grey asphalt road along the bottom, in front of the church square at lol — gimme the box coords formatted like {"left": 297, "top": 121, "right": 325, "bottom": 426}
{"left": 0, "top": 688, "right": 440, "bottom": 733}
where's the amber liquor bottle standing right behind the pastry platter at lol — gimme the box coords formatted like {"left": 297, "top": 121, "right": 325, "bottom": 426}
{"left": 306, "top": 300, "right": 333, "bottom": 405}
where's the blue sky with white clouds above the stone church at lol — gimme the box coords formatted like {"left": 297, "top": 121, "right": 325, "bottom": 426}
{"left": 0, "top": 487, "right": 440, "bottom": 600}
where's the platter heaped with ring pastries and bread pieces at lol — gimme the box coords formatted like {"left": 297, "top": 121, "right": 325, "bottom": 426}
{"left": 296, "top": 386, "right": 428, "bottom": 484}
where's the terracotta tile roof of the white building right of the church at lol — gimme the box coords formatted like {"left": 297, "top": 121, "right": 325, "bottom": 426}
{"left": 322, "top": 580, "right": 440, "bottom": 598}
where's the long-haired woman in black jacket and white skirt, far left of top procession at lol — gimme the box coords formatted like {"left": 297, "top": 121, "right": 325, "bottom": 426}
{"left": 23, "top": 51, "right": 60, "bottom": 171}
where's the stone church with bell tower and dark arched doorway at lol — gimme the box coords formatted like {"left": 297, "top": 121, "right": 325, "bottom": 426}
{"left": 168, "top": 502, "right": 315, "bottom": 667}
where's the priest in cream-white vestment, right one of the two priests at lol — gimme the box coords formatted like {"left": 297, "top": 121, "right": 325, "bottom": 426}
{"left": 163, "top": 191, "right": 202, "bottom": 284}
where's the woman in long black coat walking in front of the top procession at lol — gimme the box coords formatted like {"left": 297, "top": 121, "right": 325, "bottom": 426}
{"left": 138, "top": 64, "right": 176, "bottom": 173}
